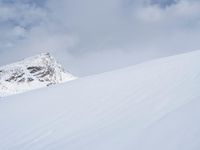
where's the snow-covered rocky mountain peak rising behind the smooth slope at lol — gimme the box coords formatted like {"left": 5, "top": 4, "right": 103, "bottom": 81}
{"left": 0, "top": 53, "right": 76, "bottom": 97}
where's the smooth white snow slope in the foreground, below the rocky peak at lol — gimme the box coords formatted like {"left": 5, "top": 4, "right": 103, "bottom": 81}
{"left": 0, "top": 51, "right": 200, "bottom": 150}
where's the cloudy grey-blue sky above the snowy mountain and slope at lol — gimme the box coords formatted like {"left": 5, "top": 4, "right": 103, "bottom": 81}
{"left": 0, "top": 0, "right": 200, "bottom": 77}
